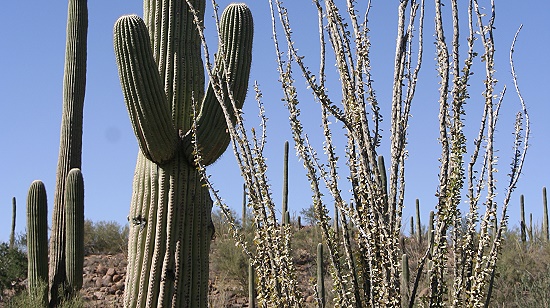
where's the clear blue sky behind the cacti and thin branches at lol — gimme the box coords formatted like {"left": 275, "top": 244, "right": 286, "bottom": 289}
{"left": 0, "top": 0, "right": 550, "bottom": 241}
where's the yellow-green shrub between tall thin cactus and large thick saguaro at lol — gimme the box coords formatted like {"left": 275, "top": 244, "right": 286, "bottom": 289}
{"left": 84, "top": 220, "right": 129, "bottom": 254}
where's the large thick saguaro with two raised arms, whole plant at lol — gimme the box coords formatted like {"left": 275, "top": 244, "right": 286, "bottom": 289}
{"left": 114, "top": 0, "right": 253, "bottom": 307}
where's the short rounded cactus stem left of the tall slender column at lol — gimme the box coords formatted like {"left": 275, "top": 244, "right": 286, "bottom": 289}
{"left": 27, "top": 181, "right": 48, "bottom": 307}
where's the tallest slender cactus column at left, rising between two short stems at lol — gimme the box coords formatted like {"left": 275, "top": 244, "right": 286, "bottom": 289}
{"left": 49, "top": 0, "right": 88, "bottom": 305}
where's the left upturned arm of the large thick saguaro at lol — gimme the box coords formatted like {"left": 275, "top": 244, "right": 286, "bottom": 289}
{"left": 114, "top": 15, "right": 178, "bottom": 163}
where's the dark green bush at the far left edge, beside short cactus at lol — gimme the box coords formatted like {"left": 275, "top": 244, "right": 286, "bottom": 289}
{"left": 0, "top": 243, "right": 27, "bottom": 290}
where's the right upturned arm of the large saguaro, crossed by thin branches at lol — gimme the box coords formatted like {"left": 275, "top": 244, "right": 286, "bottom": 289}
{"left": 183, "top": 4, "right": 254, "bottom": 165}
